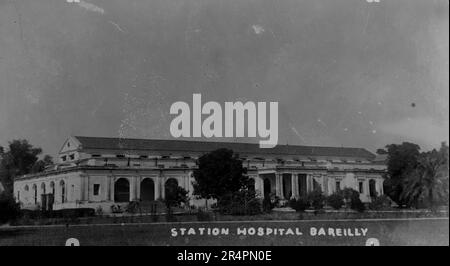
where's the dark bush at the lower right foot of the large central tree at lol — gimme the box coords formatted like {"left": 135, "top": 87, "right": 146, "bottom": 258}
{"left": 217, "top": 190, "right": 262, "bottom": 215}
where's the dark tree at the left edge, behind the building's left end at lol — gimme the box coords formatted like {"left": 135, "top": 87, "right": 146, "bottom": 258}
{"left": 0, "top": 140, "right": 51, "bottom": 193}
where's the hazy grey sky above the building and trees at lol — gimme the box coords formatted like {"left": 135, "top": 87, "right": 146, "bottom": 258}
{"left": 0, "top": 0, "right": 449, "bottom": 155}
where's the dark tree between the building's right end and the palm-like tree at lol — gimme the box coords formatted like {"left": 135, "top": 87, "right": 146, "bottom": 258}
{"left": 384, "top": 142, "right": 420, "bottom": 206}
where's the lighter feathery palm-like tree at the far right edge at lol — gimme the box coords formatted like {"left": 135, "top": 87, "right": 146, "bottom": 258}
{"left": 401, "top": 143, "right": 449, "bottom": 208}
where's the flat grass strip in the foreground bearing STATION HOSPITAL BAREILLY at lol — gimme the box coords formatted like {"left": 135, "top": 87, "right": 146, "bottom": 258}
{"left": 0, "top": 218, "right": 449, "bottom": 246}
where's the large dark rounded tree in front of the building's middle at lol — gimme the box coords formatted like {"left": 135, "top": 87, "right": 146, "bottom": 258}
{"left": 193, "top": 149, "right": 249, "bottom": 204}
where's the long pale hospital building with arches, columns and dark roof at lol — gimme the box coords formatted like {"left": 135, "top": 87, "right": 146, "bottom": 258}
{"left": 14, "top": 136, "right": 386, "bottom": 212}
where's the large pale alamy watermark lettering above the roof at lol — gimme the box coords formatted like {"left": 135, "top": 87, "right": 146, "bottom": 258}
{"left": 170, "top": 94, "right": 278, "bottom": 148}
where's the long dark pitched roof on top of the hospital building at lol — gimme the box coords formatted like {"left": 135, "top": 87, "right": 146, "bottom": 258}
{"left": 75, "top": 136, "right": 375, "bottom": 160}
